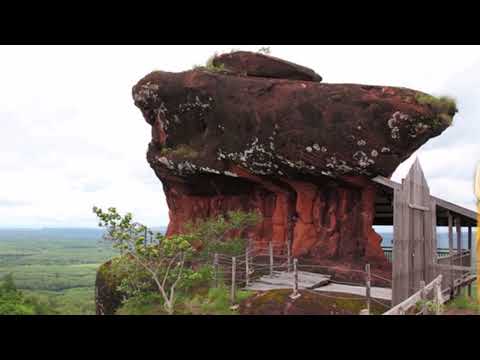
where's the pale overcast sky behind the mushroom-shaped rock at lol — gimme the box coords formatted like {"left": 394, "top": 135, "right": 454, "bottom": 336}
{"left": 0, "top": 45, "right": 480, "bottom": 227}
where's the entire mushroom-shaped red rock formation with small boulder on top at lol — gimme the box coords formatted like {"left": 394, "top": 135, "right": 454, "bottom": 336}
{"left": 133, "top": 52, "right": 456, "bottom": 263}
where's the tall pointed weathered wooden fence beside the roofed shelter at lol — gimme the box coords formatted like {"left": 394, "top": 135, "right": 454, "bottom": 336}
{"left": 390, "top": 159, "right": 476, "bottom": 308}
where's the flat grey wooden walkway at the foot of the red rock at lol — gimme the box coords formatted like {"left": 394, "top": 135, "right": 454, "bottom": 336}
{"left": 245, "top": 271, "right": 392, "bottom": 300}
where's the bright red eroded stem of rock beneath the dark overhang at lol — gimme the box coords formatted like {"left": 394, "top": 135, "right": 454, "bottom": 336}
{"left": 161, "top": 167, "right": 385, "bottom": 263}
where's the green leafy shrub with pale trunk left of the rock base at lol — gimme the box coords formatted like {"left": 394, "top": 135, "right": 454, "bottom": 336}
{"left": 93, "top": 207, "right": 259, "bottom": 314}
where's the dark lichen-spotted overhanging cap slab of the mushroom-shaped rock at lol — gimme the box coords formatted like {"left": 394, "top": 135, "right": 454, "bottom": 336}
{"left": 133, "top": 61, "right": 455, "bottom": 183}
